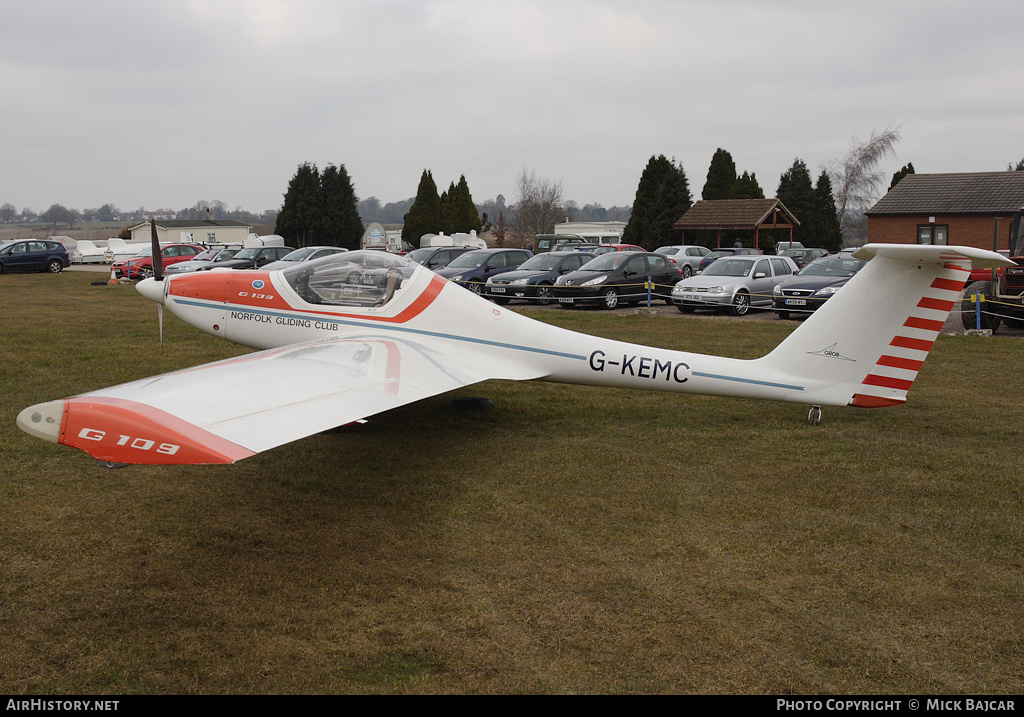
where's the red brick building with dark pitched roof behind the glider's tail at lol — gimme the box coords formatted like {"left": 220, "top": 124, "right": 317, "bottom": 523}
{"left": 866, "top": 172, "right": 1024, "bottom": 250}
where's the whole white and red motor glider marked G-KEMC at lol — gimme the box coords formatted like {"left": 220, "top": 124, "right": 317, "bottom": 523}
{"left": 17, "top": 244, "right": 1010, "bottom": 464}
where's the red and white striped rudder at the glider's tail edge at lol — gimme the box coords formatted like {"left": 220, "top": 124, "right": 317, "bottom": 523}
{"left": 850, "top": 255, "right": 971, "bottom": 408}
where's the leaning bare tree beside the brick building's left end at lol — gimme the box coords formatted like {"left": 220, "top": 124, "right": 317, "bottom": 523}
{"left": 825, "top": 125, "right": 901, "bottom": 231}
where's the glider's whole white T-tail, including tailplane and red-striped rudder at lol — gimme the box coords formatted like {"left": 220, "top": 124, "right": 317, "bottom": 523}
{"left": 761, "top": 244, "right": 1013, "bottom": 408}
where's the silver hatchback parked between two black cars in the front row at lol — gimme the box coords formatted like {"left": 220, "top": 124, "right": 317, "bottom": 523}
{"left": 672, "top": 254, "right": 797, "bottom": 317}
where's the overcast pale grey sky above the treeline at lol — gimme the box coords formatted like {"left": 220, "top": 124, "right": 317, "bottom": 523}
{"left": 0, "top": 0, "right": 1024, "bottom": 212}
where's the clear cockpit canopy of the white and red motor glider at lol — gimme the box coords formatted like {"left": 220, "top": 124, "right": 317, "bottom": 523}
{"left": 283, "top": 251, "right": 417, "bottom": 308}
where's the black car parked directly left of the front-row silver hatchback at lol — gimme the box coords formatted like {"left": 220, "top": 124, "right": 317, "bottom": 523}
{"left": 554, "top": 251, "right": 683, "bottom": 308}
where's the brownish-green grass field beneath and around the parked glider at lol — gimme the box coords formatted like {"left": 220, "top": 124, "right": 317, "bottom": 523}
{"left": 0, "top": 272, "right": 1024, "bottom": 694}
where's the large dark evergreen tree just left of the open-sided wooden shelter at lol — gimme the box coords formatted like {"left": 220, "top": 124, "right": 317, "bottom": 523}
{"left": 623, "top": 155, "right": 692, "bottom": 251}
